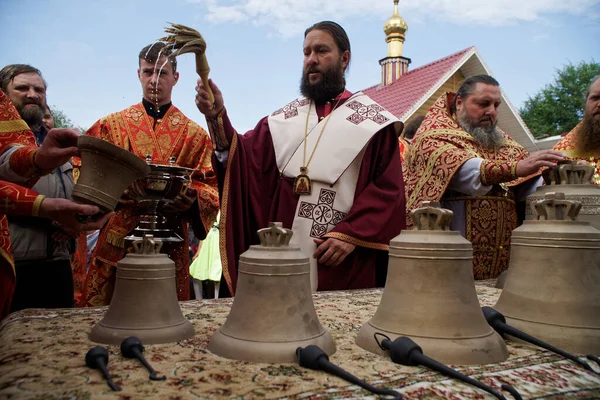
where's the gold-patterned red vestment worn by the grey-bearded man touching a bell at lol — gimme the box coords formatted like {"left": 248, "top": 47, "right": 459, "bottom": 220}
{"left": 405, "top": 93, "right": 539, "bottom": 279}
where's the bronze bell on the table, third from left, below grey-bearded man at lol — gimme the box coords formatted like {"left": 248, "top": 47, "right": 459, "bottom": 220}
{"left": 356, "top": 201, "right": 508, "bottom": 364}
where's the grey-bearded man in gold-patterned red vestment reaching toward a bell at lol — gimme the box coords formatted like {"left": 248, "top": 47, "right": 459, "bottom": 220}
{"left": 405, "top": 75, "right": 564, "bottom": 279}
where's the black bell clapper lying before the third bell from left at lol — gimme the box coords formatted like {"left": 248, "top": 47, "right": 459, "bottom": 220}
{"left": 375, "top": 333, "right": 522, "bottom": 400}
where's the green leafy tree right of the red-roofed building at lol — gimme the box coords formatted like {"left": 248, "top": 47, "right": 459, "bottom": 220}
{"left": 519, "top": 60, "right": 600, "bottom": 137}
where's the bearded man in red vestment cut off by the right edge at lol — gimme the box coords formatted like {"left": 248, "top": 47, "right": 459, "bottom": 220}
{"left": 554, "top": 76, "right": 600, "bottom": 185}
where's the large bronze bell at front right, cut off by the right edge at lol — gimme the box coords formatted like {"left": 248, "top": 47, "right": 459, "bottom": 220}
{"left": 494, "top": 193, "right": 600, "bottom": 354}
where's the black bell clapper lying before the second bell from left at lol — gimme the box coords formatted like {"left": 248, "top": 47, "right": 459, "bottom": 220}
{"left": 296, "top": 344, "right": 403, "bottom": 400}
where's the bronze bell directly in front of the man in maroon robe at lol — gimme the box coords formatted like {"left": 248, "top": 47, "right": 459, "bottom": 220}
{"left": 208, "top": 222, "right": 336, "bottom": 363}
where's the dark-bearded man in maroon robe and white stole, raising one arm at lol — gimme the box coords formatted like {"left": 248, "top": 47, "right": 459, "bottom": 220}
{"left": 196, "top": 21, "right": 405, "bottom": 294}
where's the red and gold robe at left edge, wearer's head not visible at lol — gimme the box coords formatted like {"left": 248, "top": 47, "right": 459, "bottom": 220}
{"left": 0, "top": 90, "right": 44, "bottom": 319}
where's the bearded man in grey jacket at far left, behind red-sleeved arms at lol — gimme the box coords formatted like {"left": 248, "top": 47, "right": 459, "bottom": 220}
{"left": 0, "top": 64, "right": 82, "bottom": 311}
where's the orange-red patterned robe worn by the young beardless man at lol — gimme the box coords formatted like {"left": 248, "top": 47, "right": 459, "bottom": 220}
{"left": 80, "top": 103, "right": 219, "bottom": 306}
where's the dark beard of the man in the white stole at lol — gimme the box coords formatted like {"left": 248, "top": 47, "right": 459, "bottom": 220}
{"left": 300, "top": 63, "right": 346, "bottom": 103}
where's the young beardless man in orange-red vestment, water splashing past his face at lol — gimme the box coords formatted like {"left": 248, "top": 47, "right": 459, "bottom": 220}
{"left": 80, "top": 43, "right": 219, "bottom": 306}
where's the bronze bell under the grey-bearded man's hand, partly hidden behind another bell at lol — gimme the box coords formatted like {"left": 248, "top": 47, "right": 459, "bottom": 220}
{"left": 525, "top": 160, "right": 600, "bottom": 230}
